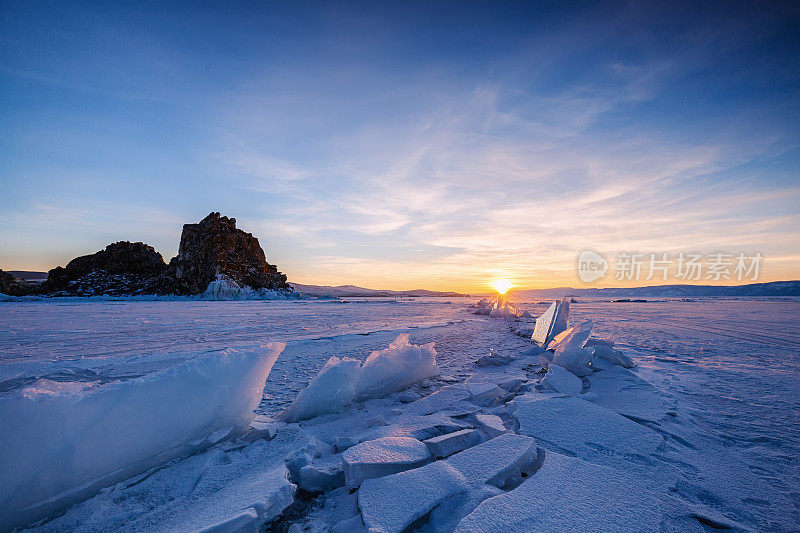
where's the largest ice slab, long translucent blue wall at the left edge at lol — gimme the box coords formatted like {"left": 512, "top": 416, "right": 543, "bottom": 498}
{"left": 0, "top": 343, "right": 285, "bottom": 529}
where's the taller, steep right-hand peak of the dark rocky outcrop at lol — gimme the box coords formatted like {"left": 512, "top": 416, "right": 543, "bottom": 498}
{"left": 170, "top": 213, "right": 291, "bottom": 294}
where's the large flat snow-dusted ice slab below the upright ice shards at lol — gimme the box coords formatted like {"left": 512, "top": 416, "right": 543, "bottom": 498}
{"left": 514, "top": 394, "right": 664, "bottom": 460}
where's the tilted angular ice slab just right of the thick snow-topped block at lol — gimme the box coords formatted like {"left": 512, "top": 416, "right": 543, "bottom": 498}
{"left": 445, "top": 433, "right": 538, "bottom": 488}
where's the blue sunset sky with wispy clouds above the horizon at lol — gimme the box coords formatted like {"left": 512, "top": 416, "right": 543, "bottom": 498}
{"left": 0, "top": 0, "right": 800, "bottom": 291}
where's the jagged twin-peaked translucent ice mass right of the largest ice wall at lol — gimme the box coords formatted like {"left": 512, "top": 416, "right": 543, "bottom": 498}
{"left": 283, "top": 333, "right": 439, "bottom": 421}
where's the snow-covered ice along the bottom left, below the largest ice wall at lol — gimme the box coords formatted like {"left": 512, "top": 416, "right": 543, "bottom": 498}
{"left": 34, "top": 427, "right": 316, "bottom": 532}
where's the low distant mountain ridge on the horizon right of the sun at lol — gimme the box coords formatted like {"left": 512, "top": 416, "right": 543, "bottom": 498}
{"left": 514, "top": 280, "right": 800, "bottom": 298}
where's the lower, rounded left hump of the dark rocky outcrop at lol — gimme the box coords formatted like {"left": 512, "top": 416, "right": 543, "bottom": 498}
{"left": 41, "top": 241, "right": 175, "bottom": 296}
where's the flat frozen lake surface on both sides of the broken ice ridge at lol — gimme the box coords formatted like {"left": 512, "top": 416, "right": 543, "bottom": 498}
{"left": 0, "top": 298, "right": 800, "bottom": 530}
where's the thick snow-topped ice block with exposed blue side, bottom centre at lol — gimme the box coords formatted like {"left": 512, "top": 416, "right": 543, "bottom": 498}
{"left": 342, "top": 437, "right": 431, "bottom": 488}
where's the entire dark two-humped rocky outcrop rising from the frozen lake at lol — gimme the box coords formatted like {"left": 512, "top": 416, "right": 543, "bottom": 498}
{"left": 36, "top": 213, "right": 291, "bottom": 296}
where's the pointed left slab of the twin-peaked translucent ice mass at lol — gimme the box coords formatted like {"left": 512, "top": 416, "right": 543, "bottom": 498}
{"left": 284, "top": 357, "right": 361, "bottom": 422}
